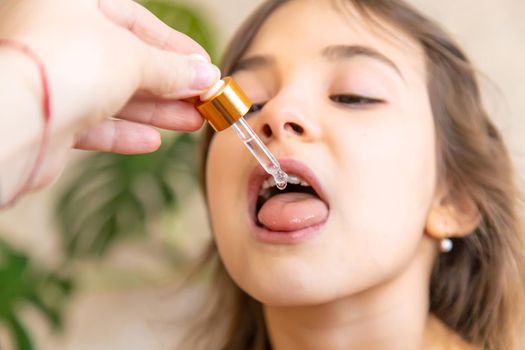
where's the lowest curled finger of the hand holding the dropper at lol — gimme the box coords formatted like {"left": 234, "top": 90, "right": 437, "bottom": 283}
{"left": 75, "top": 120, "right": 161, "bottom": 154}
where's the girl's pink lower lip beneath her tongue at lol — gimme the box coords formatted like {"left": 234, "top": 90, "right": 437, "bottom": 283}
{"left": 249, "top": 222, "right": 326, "bottom": 245}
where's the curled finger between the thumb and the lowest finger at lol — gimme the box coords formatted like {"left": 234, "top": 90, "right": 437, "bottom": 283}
{"left": 117, "top": 98, "right": 204, "bottom": 131}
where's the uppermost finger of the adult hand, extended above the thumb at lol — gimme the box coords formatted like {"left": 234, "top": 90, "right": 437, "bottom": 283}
{"left": 99, "top": 0, "right": 210, "bottom": 61}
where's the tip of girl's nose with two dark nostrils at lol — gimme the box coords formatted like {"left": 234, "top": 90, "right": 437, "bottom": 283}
{"left": 255, "top": 95, "right": 320, "bottom": 142}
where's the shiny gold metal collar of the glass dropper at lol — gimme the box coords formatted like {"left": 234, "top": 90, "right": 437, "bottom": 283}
{"left": 195, "top": 77, "right": 252, "bottom": 131}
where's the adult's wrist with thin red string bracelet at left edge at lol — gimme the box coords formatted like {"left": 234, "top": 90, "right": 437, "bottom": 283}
{"left": 0, "top": 38, "right": 51, "bottom": 207}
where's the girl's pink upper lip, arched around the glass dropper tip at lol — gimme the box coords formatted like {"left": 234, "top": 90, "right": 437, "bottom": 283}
{"left": 248, "top": 158, "right": 328, "bottom": 220}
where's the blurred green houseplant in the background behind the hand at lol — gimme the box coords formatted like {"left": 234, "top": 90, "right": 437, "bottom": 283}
{"left": 0, "top": 0, "right": 215, "bottom": 350}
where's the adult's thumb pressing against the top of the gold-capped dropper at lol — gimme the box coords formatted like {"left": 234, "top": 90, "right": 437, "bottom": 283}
{"left": 139, "top": 45, "right": 221, "bottom": 99}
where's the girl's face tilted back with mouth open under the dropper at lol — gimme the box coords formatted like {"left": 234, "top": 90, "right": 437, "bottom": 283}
{"left": 207, "top": 1, "right": 436, "bottom": 305}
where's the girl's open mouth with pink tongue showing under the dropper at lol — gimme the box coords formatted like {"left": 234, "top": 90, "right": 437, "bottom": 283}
{"left": 249, "top": 160, "right": 329, "bottom": 233}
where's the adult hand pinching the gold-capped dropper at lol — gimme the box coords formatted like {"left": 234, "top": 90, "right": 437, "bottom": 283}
{"left": 0, "top": 0, "right": 220, "bottom": 205}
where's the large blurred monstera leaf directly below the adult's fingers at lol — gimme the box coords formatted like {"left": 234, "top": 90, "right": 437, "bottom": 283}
{"left": 56, "top": 134, "right": 195, "bottom": 258}
